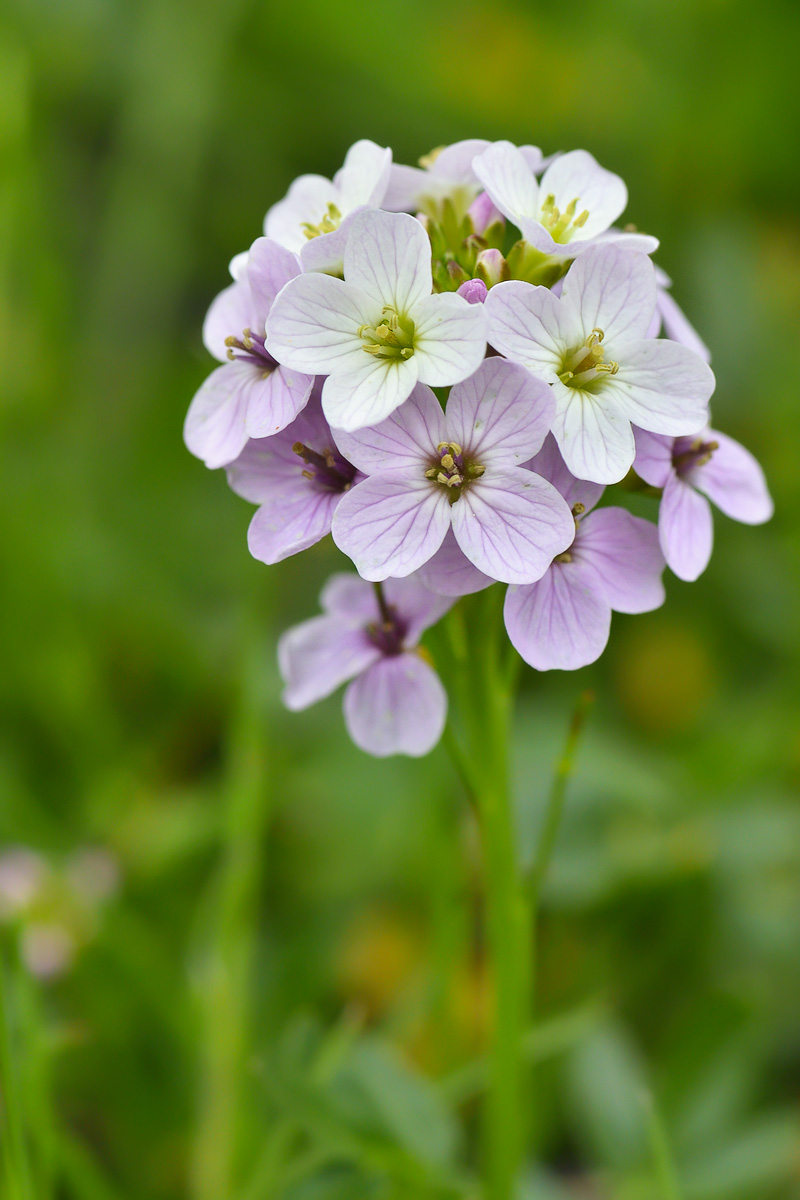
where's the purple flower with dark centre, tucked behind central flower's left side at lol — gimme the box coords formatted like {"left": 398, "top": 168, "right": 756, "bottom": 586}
{"left": 228, "top": 395, "right": 362, "bottom": 565}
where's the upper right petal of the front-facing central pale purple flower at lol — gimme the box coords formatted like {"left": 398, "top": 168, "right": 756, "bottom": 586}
{"left": 446, "top": 358, "right": 555, "bottom": 467}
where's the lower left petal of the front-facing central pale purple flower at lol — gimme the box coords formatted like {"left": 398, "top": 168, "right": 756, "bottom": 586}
{"left": 331, "top": 472, "right": 450, "bottom": 582}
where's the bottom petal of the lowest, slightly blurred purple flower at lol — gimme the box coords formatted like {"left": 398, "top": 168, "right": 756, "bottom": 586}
{"left": 344, "top": 654, "right": 447, "bottom": 758}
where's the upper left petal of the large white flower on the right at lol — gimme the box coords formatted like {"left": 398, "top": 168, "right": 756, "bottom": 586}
{"left": 483, "top": 280, "right": 575, "bottom": 383}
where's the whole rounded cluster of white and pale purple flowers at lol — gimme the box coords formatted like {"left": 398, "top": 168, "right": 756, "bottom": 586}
{"left": 185, "top": 139, "right": 771, "bottom": 755}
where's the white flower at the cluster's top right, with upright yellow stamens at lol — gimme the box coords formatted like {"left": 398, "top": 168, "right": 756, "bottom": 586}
{"left": 473, "top": 142, "right": 658, "bottom": 258}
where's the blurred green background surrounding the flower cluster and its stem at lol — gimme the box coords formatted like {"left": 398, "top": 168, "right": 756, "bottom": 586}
{"left": 0, "top": 0, "right": 800, "bottom": 1200}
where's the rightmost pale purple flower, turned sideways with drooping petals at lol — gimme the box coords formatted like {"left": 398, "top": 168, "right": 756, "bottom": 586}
{"left": 633, "top": 428, "right": 772, "bottom": 581}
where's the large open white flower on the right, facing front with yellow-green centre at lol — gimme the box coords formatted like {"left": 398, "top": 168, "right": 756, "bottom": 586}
{"left": 483, "top": 243, "right": 714, "bottom": 484}
